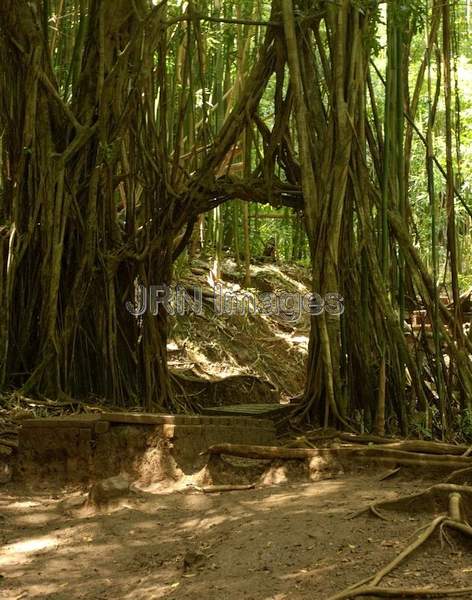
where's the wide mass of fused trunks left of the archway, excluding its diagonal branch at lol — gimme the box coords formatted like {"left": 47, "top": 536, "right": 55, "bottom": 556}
{"left": 0, "top": 0, "right": 181, "bottom": 409}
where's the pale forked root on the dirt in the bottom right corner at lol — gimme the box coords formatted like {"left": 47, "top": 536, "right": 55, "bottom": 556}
{"left": 328, "top": 492, "right": 472, "bottom": 600}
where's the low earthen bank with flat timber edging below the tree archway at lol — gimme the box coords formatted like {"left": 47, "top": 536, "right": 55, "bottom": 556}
{"left": 14, "top": 413, "right": 276, "bottom": 487}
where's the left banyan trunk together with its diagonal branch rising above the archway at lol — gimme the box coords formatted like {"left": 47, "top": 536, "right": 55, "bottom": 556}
{"left": 0, "top": 0, "right": 274, "bottom": 409}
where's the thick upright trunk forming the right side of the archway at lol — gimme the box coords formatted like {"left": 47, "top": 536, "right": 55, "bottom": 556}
{"left": 284, "top": 0, "right": 365, "bottom": 426}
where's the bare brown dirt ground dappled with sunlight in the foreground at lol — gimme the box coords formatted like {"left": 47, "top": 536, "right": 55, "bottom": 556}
{"left": 0, "top": 472, "right": 472, "bottom": 600}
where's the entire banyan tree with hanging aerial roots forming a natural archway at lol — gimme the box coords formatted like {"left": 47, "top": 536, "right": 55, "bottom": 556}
{"left": 0, "top": 0, "right": 472, "bottom": 433}
